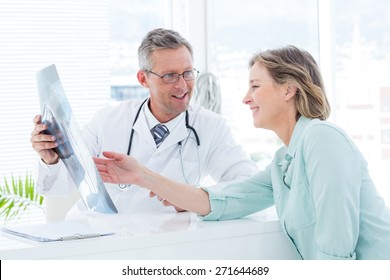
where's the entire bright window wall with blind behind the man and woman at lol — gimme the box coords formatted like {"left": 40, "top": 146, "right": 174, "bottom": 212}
{"left": 0, "top": 0, "right": 390, "bottom": 208}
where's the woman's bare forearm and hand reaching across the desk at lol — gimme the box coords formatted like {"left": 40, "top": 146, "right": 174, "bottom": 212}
{"left": 94, "top": 152, "right": 211, "bottom": 216}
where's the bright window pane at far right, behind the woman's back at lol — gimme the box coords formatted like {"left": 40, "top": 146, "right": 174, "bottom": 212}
{"left": 329, "top": 0, "right": 390, "bottom": 202}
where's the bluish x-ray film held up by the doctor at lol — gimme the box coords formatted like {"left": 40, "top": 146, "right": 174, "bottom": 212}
{"left": 37, "top": 64, "right": 118, "bottom": 213}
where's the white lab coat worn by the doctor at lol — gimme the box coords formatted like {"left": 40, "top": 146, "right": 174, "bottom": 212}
{"left": 36, "top": 100, "right": 258, "bottom": 213}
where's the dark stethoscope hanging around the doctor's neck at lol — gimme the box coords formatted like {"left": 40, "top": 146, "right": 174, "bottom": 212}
{"left": 118, "top": 98, "right": 200, "bottom": 189}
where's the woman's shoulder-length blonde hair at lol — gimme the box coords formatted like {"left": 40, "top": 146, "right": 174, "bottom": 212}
{"left": 249, "top": 46, "right": 330, "bottom": 120}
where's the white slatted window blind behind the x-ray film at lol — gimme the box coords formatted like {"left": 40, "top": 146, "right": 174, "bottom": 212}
{"left": 0, "top": 0, "right": 110, "bottom": 181}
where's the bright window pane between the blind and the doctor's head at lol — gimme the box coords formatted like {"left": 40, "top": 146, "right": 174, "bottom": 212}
{"left": 110, "top": 0, "right": 167, "bottom": 100}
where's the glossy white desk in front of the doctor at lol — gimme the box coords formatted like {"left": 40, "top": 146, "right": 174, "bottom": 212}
{"left": 0, "top": 210, "right": 299, "bottom": 260}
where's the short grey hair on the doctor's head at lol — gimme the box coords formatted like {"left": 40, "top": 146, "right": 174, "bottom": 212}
{"left": 138, "top": 28, "right": 193, "bottom": 70}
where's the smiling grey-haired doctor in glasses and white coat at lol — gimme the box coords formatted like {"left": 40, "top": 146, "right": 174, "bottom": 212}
{"left": 31, "top": 28, "right": 258, "bottom": 213}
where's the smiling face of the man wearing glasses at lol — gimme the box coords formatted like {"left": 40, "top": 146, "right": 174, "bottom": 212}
{"left": 139, "top": 46, "right": 195, "bottom": 122}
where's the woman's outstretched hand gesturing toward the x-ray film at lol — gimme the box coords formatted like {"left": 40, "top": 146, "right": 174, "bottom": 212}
{"left": 93, "top": 152, "right": 143, "bottom": 184}
